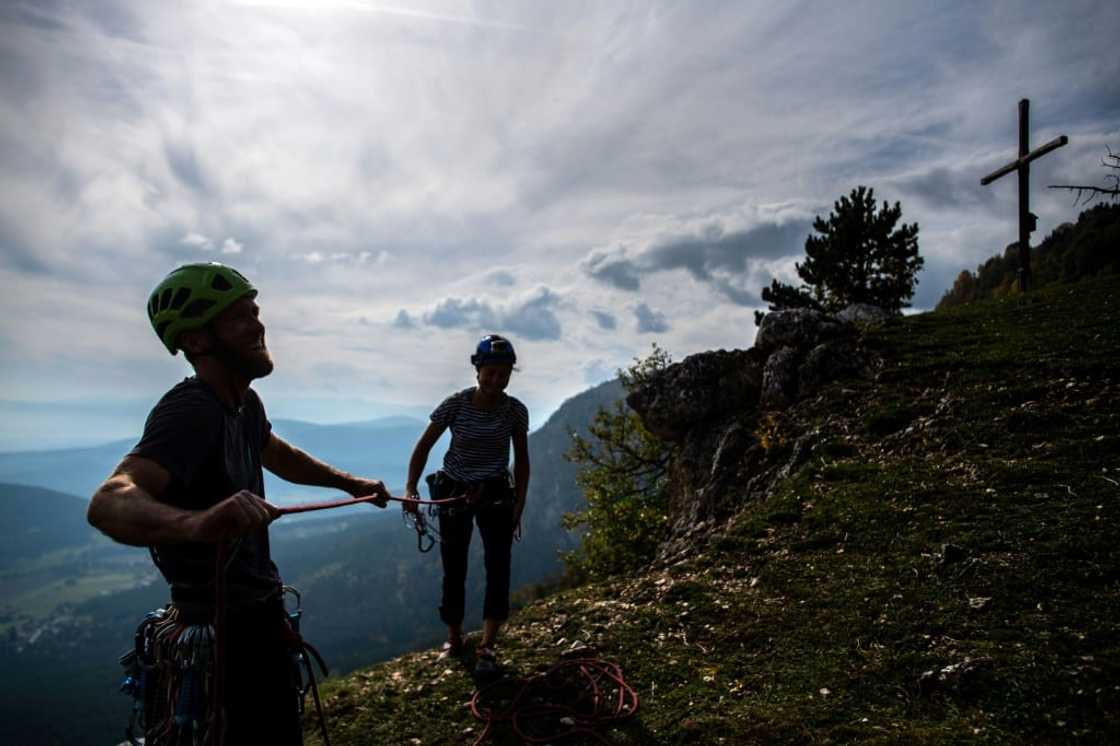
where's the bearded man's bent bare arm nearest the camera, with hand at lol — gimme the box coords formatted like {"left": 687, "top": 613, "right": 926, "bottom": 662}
{"left": 86, "top": 456, "right": 278, "bottom": 547}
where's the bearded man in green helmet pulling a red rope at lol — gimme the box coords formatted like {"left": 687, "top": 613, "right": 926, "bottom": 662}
{"left": 88, "top": 262, "right": 389, "bottom": 744}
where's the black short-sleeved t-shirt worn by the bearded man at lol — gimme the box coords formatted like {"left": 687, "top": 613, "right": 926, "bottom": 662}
{"left": 130, "top": 377, "right": 281, "bottom": 604}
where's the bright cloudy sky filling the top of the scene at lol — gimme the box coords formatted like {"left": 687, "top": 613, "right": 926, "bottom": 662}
{"left": 0, "top": 0, "right": 1120, "bottom": 448}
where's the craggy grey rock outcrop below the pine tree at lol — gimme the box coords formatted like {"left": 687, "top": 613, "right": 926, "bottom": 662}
{"left": 626, "top": 307, "right": 892, "bottom": 557}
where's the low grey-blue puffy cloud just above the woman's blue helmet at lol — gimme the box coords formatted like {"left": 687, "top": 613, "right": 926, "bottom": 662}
{"left": 403, "top": 287, "right": 562, "bottom": 341}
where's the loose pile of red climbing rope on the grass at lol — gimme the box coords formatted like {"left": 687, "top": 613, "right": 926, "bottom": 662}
{"left": 470, "top": 658, "right": 638, "bottom": 746}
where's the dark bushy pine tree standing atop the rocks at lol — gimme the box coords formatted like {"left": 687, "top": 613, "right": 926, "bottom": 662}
{"left": 755, "top": 186, "right": 924, "bottom": 323}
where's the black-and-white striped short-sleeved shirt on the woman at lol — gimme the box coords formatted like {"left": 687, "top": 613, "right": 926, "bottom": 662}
{"left": 431, "top": 386, "right": 529, "bottom": 483}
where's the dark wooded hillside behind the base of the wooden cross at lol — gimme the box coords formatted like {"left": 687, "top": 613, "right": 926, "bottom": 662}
{"left": 937, "top": 200, "right": 1120, "bottom": 310}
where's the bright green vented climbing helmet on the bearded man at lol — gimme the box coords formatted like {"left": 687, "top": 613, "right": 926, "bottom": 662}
{"left": 148, "top": 262, "right": 256, "bottom": 355}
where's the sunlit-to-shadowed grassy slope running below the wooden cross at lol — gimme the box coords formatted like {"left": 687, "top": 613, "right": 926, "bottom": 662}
{"left": 309, "top": 274, "right": 1120, "bottom": 746}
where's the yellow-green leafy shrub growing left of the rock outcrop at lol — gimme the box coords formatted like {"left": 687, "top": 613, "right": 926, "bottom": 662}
{"left": 563, "top": 345, "right": 672, "bottom": 578}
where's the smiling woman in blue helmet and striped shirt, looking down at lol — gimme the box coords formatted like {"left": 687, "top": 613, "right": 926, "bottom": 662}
{"left": 405, "top": 334, "right": 529, "bottom": 674}
